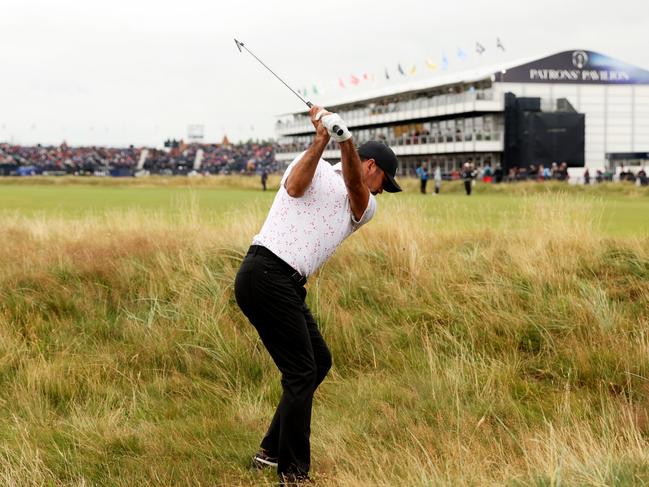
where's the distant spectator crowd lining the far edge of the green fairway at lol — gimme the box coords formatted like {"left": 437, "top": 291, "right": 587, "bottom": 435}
{"left": 0, "top": 139, "right": 649, "bottom": 192}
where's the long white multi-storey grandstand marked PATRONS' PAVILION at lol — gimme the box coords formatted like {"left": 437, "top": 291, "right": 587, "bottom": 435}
{"left": 276, "top": 50, "right": 649, "bottom": 175}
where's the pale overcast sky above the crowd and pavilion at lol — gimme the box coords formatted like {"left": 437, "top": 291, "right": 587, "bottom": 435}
{"left": 0, "top": 0, "right": 649, "bottom": 146}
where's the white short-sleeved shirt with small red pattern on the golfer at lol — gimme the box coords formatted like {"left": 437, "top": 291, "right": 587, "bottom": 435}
{"left": 252, "top": 153, "right": 376, "bottom": 277}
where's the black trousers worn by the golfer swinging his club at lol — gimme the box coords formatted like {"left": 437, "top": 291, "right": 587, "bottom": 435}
{"left": 234, "top": 247, "right": 331, "bottom": 476}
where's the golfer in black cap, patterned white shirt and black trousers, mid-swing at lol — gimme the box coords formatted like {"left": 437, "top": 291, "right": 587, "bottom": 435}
{"left": 235, "top": 106, "right": 401, "bottom": 485}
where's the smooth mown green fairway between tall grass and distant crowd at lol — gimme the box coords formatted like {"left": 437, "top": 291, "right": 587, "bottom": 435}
{"left": 0, "top": 180, "right": 649, "bottom": 237}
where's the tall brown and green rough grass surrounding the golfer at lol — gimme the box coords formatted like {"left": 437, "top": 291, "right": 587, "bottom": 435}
{"left": 0, "top": 194, "right": 649, "bottom": 486}
